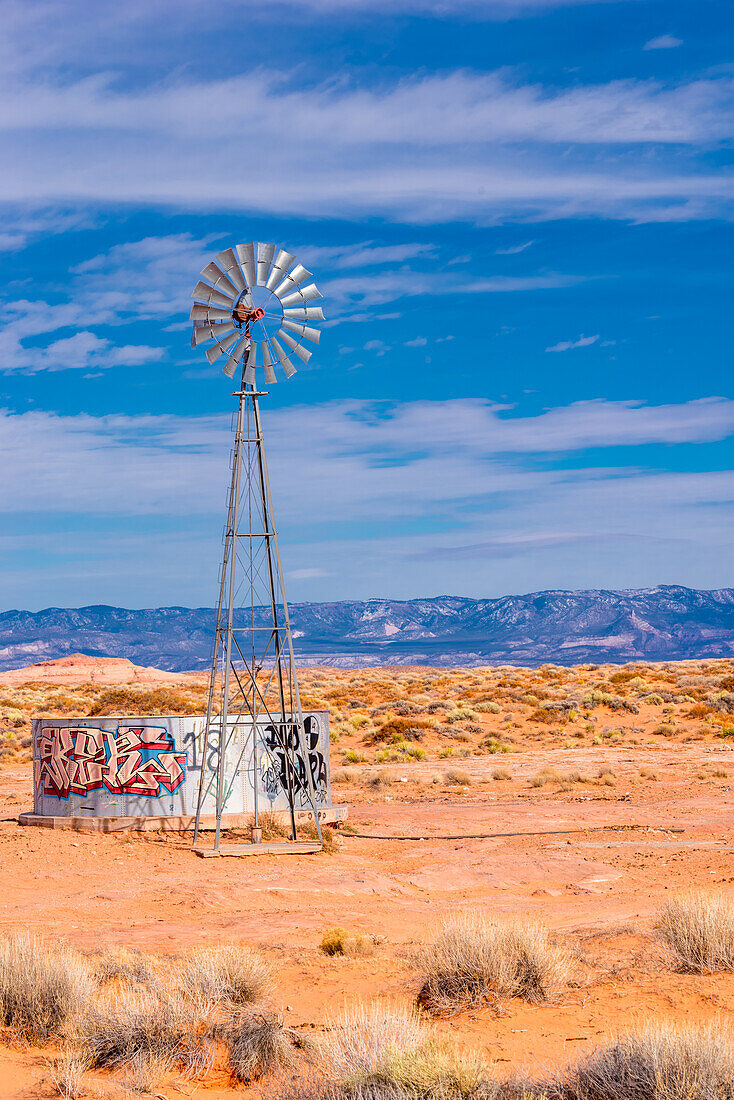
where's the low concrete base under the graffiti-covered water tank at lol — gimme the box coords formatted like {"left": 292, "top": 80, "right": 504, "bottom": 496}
{"left": 18, "top": 805, "right": 349, "bottom": 831}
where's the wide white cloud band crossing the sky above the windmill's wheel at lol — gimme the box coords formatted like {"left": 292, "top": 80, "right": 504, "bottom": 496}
{"left": 0, "top": 64, "right": 734, "bottom": 225}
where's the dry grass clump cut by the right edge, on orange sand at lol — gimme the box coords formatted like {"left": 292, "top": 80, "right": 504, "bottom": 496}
{"left": 656, "top": 891, "right": 734, "bottom": 974}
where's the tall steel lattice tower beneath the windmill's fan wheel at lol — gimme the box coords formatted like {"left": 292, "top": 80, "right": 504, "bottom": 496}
{"left": 194, "top": 343, "right": 321, "bottom": 849}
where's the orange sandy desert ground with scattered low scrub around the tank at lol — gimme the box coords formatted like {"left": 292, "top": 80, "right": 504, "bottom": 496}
{"left": 0, "top": 657, "right": 734, "bottom": 1100}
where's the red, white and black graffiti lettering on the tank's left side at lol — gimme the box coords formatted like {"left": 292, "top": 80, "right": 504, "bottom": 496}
{"left": 37, "top": 725, "right": 188, "bottom": 799}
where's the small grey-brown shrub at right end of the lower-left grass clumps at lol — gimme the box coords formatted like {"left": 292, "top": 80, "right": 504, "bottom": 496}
{"left": 224, "top": 1012, "right": 304, "bottom": 1085}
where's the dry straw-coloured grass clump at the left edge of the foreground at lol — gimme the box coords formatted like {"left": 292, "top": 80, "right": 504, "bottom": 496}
{"left": 0, "top": 933, "right": 94, "bottom": 1042}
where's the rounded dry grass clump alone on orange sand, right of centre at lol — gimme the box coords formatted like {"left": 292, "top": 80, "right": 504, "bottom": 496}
{"left": 418, "top": 914, "right": 570, "bottom": 1013}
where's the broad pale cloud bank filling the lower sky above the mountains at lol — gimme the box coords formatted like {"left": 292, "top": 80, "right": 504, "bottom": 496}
{"left": 0, "top": 398, "right": 734, "bottom": 605}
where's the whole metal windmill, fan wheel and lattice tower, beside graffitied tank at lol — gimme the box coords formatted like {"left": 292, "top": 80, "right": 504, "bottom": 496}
{"left": 190, "top": 243, "right": 324, "bottom": 853}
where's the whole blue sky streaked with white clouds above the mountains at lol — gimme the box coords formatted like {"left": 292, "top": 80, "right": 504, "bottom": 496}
{"left": 0, "top": 0, "right": 734, "bottom": 609}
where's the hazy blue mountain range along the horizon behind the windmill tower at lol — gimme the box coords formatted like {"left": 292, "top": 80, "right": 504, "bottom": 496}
{"left": 0, "top": 585, "right": 734, "bottom": 672}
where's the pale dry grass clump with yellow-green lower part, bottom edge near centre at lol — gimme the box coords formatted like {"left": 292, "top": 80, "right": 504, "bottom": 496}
{"left": 321, "top": 1003, "right": 486, "bottom": 1100}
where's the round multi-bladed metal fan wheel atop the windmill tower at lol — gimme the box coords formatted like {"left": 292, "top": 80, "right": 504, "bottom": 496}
{"left": 190, "top": 241, "right": 324, "bottom": 386}
